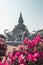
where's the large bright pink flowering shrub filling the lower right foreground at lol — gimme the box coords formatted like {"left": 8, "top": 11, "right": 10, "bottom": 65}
{"left": 0, "top": 34, "right": 43, "bottom": 65}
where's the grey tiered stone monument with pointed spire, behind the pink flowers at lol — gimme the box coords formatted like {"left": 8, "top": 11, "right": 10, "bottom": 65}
{"left": 4, "top": 13, "right": 30, "bottom": 44}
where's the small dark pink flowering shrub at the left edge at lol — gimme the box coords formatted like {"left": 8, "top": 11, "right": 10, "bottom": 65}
{"left": 0, "top": 38, "right": 7, "bottom": 60}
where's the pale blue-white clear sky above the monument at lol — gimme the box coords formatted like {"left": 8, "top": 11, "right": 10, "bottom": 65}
{"left": 0, "top": 0, "right": 43, "bottom": 34}
